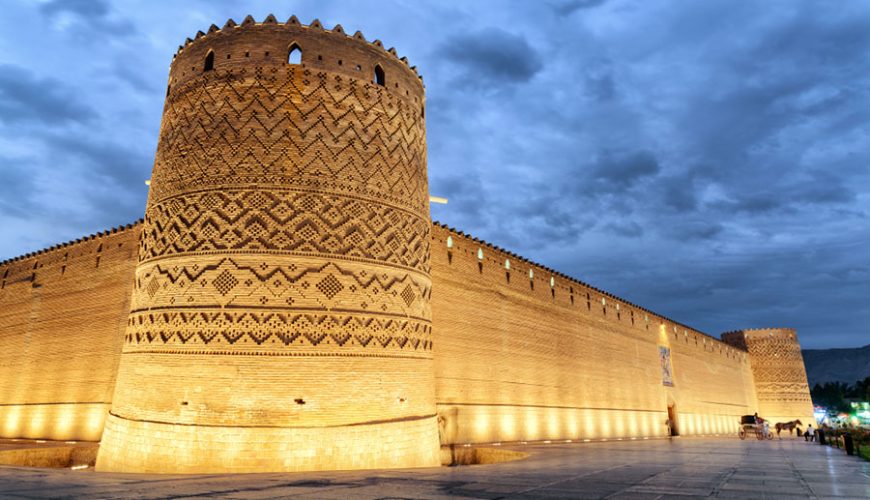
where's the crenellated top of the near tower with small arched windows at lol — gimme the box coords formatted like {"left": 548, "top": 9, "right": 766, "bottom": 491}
{"left": 167, "top": 14, "right": 423, "bottom": 102}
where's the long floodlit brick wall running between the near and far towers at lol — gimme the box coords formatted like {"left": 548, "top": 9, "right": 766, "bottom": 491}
{"left": 432, "top": 224, "right": 755, "bottom": 444}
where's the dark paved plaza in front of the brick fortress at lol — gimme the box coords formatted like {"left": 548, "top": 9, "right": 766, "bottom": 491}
{"left": 0, "top": 437, "right": 870, "bottom": 499}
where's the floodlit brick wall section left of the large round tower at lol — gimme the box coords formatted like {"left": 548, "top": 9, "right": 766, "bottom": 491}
{"left": 0, "top": 223, "right": 140, "bottom": 441}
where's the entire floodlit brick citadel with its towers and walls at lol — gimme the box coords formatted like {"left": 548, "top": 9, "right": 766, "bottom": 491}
{"left": 0, "top": 15, "right": 813, "bottom": 473}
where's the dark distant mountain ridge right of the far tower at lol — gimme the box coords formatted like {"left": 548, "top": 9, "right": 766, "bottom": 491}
{"left": 801, "top": 344, "right": 870, "bottom": 387}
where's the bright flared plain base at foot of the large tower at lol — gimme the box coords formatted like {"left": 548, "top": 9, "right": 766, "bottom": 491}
{"left": 97, "top": 415, "right": 439, "bottom": 474}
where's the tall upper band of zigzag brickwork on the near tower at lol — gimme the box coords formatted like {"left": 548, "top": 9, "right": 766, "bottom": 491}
{"left": 152, "top": 65, "right": 428, "bottom": 214}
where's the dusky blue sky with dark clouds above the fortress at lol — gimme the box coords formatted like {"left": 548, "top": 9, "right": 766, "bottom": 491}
{"left": 0, "top": 0, "right": 870, "bottom": 348}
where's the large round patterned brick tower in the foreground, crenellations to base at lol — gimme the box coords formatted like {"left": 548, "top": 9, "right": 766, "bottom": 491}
{"left": 97, "top": 15, "right": 439, "bottom": 473}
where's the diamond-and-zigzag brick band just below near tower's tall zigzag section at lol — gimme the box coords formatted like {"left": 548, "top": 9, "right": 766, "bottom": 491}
{"left": 140, "top": 190, "right": 430, "bottom": 273}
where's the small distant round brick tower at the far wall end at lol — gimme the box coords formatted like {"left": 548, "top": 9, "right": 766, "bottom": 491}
{"left": 722, "top": 328, "right": 815, "bottom": 425}
